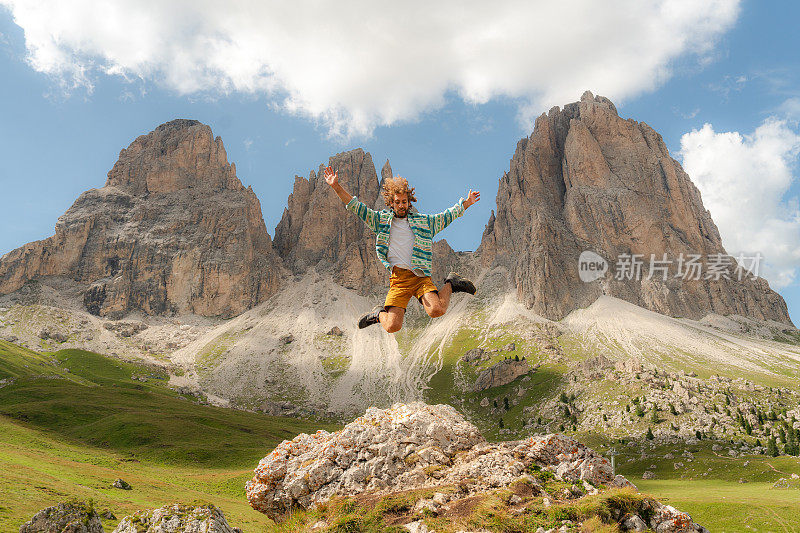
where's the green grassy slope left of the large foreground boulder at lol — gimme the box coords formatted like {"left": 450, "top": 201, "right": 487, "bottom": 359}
{"left": 0, "top": 341, "right": 335, "bottom": 531}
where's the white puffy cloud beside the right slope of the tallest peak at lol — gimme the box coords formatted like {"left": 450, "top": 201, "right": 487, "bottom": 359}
{"left": 680, "top": 117, "right": 800, "bottom": 288}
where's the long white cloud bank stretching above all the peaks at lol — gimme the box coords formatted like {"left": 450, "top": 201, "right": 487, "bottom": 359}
{"left": 0, "top": 0, "right": 739, "bottom": 135}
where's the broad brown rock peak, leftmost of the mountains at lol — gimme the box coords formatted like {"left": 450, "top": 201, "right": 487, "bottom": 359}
{"left": 0, "top": 120, "right": 280, "bottom": 316}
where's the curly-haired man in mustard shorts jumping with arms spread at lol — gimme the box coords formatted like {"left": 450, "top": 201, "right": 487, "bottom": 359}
{"left": 325, "top": 167, "right": 481, "bottom": 333}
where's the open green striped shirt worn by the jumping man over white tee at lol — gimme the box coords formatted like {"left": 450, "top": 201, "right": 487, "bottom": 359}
{"left": 345, "top": 196, "right": 464, "bottom": 276}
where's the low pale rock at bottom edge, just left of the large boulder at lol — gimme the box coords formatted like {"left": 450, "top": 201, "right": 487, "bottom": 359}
{"left": 113, "top": 504, "right": 241, "bottom": 533}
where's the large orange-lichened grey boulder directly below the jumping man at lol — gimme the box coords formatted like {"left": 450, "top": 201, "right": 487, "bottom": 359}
{"left": 246, "top": 402, "right": 627, "bottom": 516}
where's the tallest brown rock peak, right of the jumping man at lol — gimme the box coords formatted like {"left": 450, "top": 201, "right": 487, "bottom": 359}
{"left": 479, "top": 91, "right": 791, "bottom": 324}
